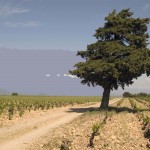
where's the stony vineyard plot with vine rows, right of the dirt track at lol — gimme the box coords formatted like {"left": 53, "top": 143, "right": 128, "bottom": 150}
{"left": 35, "top": 97, "right": 150, "bottom": 150}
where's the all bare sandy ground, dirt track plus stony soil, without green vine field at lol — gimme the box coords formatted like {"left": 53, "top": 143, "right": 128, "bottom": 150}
{"left": 0, "top": 99, "right": 149, "bottom": 150}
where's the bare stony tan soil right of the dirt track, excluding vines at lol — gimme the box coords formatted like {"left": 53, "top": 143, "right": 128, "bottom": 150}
{"left": 30, "top": 99, "right": 150, "bottom": 150}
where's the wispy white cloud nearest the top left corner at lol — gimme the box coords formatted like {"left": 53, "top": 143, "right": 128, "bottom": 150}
{"left": 0, "top": 5, "right": 30, "bottom": 16}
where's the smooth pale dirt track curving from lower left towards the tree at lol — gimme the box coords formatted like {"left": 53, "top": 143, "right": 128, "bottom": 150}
{"left": 0, "top": 99, "right": 119, "bottom": 150}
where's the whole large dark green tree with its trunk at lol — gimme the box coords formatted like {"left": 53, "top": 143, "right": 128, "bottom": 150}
{"left": 70, "top": 9, "right": 150, "bottom": 109}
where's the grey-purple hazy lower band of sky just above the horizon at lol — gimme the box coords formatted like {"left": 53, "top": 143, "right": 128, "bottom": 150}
{"left": 0, "top": 48, "right": 150, "bottom": 96}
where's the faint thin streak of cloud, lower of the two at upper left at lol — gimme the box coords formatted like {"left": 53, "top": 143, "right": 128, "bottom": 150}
{"left": 4, "top": 21, "right": 42, "bottom": 28}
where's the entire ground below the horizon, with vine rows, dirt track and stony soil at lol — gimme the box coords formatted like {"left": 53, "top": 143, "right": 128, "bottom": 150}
{"left": 0, "top": 96, "right": 150, "bottom": 150}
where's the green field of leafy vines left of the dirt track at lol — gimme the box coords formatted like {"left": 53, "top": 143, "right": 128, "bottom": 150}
{"left": 0, "top": 96, "right": 100, "bottom": 120}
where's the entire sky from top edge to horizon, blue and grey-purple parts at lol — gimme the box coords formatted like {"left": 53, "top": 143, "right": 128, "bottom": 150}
{"left": 0, "top": 0, "right": 150, "bottom": 95}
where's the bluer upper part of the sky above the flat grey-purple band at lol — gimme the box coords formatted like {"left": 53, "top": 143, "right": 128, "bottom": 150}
{"left": 0, "top": 0, "right": 150, "bottom": 51}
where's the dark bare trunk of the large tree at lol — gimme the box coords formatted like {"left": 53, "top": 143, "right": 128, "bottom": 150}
{"left": 100, "top": 87, "right": 110, "bottom": 109}
